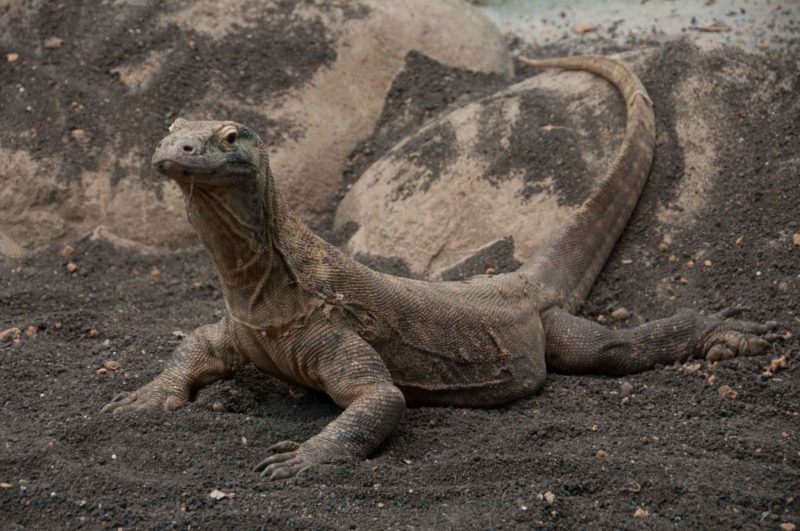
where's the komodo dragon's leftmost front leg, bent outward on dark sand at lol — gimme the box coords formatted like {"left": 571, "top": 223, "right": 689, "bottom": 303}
{"left": 101, "top": 317, "right": 243, "bottom": 413}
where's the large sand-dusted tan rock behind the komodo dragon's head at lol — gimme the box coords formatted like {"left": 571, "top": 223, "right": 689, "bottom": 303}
{"left": 0, "top": 0, "right": 512, "bottom": 255}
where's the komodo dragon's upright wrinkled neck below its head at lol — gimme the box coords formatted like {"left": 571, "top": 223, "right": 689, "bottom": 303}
{"left": 179, "top": 152, "right": 326, "bottom": 330}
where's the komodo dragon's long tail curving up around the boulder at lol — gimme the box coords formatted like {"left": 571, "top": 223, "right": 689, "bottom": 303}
{"left": 520, "top": 56, "right": 655, "bottom": 311}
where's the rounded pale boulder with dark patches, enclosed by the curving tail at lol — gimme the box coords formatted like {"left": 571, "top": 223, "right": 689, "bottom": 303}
{"left": 336, "top": 50, "right": 636, "bottom": 278}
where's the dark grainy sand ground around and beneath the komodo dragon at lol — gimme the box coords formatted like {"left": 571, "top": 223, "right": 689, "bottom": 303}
{"left": 0, "top": 40, "right": 800, "bottom": 529}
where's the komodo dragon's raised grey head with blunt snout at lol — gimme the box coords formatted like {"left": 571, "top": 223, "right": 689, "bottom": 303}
{"left": 152, "top": 118, "right": 268, "bottom": 188}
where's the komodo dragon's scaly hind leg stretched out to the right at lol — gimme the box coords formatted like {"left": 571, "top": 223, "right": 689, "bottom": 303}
{"left": 542, "top": 308, "right": 783, "bottom": 376}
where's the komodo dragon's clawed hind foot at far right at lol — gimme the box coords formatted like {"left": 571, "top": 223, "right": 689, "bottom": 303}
{"left": 698, "top": 308, "right": 784, "bottom": 361}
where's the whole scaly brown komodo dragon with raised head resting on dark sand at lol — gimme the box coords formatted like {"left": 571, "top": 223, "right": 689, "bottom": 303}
{"left": 103, "top": 56, "right": 778, "bottom": 479}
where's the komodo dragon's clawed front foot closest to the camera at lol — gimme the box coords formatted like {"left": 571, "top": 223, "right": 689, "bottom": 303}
{"left": 253, "top": 439, "right": 349, "bottom": 479}
